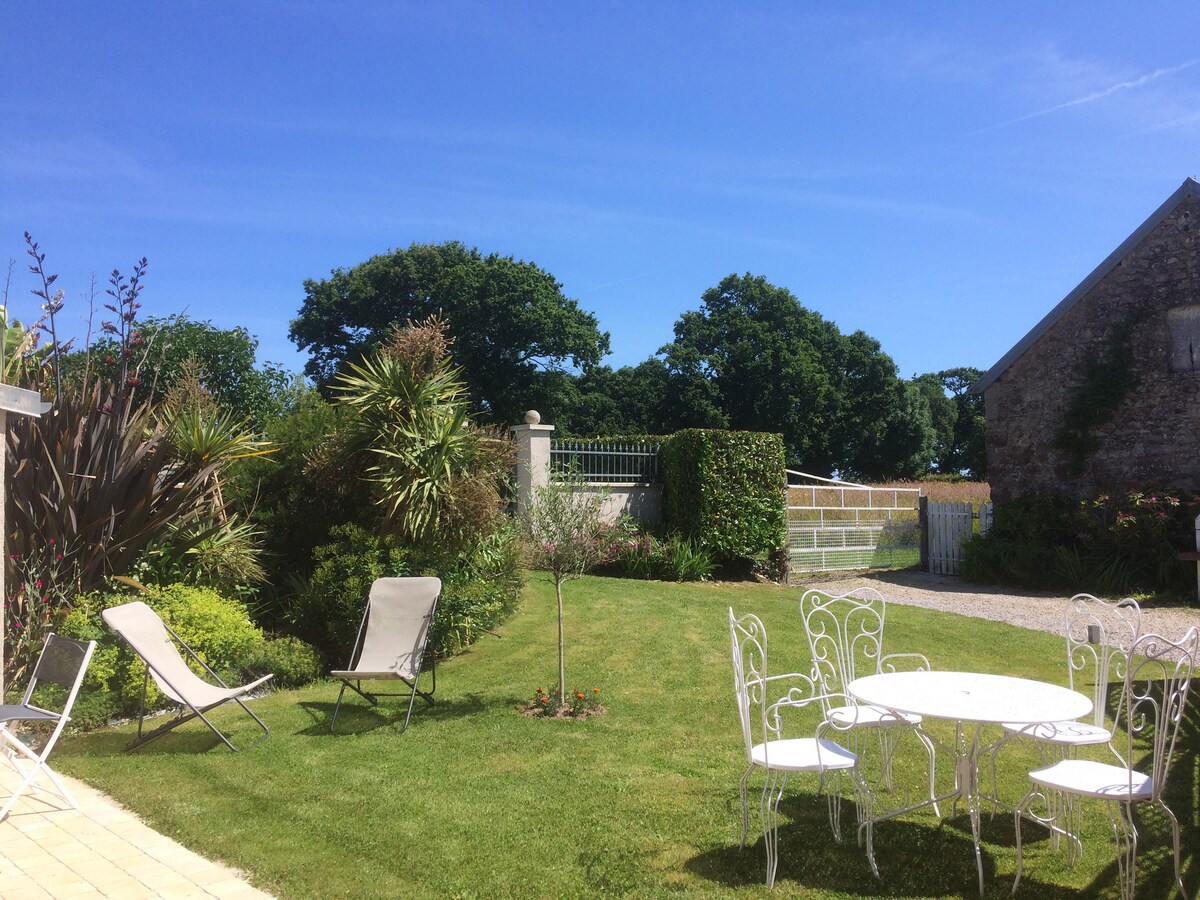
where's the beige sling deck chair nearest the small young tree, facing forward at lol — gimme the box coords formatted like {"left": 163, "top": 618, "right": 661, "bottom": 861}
{"left": 329, "top": 578, "right": 442, "bottom": 733}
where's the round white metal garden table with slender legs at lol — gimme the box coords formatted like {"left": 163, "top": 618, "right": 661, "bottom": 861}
{"left": 846, "top": 671, "right": 1092, "bottom": 896}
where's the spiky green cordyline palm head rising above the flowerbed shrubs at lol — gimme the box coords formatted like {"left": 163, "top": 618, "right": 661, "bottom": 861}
{"left": 334, "top": 343, "right": 475, "bottom": 542}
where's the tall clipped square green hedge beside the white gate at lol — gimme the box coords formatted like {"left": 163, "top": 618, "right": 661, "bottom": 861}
{"left": 661, "top": 428, "right": 786, "bottom": 577}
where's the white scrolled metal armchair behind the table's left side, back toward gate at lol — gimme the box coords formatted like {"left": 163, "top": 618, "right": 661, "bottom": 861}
{"left": 800, "top": 587, "right": 941, "bottom": 815}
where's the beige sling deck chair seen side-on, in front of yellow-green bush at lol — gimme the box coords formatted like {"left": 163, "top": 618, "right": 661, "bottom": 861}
{"left": 100, "top": 601, "right": 275, "bottom": 752}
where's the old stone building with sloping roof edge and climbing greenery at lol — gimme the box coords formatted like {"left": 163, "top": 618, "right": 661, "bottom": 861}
{"left": 971, "top": 178, "right": 1200, "bottom": 503}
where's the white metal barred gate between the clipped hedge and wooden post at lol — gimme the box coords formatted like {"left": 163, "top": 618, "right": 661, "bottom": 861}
{"left": 787, "top": 472, "right": 920, "bottom": 575}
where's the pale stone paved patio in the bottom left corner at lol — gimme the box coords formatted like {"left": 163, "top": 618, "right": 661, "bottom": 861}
{"left": 0, "top": 758, "right": 271, "bottom": 900}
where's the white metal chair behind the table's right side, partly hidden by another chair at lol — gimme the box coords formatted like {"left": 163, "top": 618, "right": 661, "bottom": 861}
{"left": 991, "top": 594, "right": 1141, "bottom": 864}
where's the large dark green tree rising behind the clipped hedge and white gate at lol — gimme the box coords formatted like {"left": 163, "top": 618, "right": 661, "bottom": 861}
{"left": 661, "top": 274, "right": 932, "bottom": 479}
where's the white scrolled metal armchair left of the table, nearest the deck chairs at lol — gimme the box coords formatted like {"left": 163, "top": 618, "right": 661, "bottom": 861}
{"left": 730, "top": 607, "right": 880, "bottom": 887}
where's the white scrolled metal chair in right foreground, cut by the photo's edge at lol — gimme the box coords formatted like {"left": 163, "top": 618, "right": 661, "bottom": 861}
{"left": 1013, "top": 626, "right": 1200, "bottom": 900}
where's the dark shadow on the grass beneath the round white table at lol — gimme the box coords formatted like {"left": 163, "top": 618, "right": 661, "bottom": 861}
{"left": 685, "top": 792, "right": 1079, "bottom": 900}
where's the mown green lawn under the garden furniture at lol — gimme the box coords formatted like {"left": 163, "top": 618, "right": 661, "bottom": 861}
{"left": 56, "top": 576, "right": 1200, "bottom": 898}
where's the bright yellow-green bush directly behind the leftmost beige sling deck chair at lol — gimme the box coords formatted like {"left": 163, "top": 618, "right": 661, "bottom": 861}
{"left": 61, "top": 584, "right": 263, "bottom": 727}
